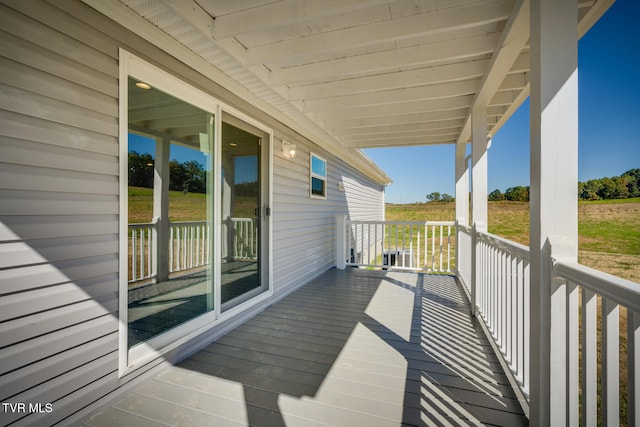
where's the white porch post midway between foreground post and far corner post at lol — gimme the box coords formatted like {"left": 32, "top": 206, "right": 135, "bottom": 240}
{"left": 471, "top": 107, "right": 488, "bottom": 316}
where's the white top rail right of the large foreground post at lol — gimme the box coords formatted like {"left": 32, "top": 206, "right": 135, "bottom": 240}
{"left": 553, "top": 261, "right": 640, "bottom": 313}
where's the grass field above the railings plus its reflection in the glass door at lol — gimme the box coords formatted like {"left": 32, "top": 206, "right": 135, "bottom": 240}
{"left": 129, "top": 187, "right": 640, "bottom": 283}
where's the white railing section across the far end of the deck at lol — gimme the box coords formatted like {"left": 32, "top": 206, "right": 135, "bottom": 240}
{"left": 338, "top": 217, "right": 455, "bottom": 273}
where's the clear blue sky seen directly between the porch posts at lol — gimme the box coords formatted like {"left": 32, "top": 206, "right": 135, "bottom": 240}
{"left": 364, "top": 0, "right": 640, "bottom": 203}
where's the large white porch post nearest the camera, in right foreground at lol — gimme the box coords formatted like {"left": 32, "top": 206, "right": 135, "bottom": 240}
{"left": 530, "top": 0, "right": 578, "bottom": 426}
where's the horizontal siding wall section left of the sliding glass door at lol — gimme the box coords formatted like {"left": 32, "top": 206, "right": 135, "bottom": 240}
{"left": 0, "top": 1, "right": 120, "bottom": 425}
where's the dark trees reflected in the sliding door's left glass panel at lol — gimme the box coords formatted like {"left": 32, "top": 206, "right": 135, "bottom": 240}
{"left": 129, "top": 150, "right": 207, "bottom": 193}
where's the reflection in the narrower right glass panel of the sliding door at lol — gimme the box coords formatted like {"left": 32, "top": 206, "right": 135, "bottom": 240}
{"left": 220, "top": 115, "right": 266, "bottom": 309}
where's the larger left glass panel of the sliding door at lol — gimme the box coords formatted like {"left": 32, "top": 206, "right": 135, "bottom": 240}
{"left": 127, "top": 78, "right": 215, "bottom": 348}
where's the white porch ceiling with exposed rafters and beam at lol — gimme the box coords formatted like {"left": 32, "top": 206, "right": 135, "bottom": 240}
{"left": 121, "top": 0, "right": 614, "bottom": 149}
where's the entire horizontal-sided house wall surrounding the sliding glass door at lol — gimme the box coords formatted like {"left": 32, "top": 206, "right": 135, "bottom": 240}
{"left": 0, "top": 0, "right": 384, "bottom": 425}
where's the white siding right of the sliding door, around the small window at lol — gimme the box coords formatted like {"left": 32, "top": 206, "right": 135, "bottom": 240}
{"left": 273, "top": 140, "right": 384, "bottom": 293}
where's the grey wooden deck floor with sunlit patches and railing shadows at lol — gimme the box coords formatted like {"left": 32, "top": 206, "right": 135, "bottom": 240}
{"left": 85, "top": 269, "right": 528, "bottom": 426}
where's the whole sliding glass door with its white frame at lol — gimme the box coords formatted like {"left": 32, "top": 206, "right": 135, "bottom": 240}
{"left": 120, "top": 52, "right": 271, "bottom": 373}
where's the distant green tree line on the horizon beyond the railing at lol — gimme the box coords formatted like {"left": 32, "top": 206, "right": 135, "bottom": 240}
{"left": 427, "top": 168, "right": 640, "bottom": 202}
